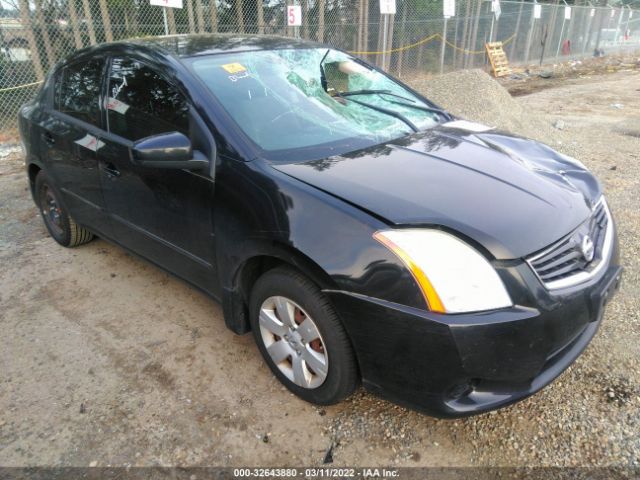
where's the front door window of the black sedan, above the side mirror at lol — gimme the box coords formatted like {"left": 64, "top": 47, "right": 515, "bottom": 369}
{"left": 107, "top": 58, "right": 189, "bottom": 141}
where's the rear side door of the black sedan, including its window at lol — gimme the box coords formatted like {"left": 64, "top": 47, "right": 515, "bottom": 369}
{"left": 39, "top": 56, "right": 110, "bottom": 235}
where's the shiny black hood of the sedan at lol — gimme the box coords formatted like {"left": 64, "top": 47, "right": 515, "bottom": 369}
{"left": 274, "top": 121, "right": 601, "bottom": 259}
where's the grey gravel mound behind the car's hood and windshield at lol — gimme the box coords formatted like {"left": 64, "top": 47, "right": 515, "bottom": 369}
{"left": 409, "top": 70, "right": 554, "bottom": 142}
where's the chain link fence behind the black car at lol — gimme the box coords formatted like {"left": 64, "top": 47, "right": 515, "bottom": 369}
{"left": 0, "top": 0, "right": 640, "bottom": 129}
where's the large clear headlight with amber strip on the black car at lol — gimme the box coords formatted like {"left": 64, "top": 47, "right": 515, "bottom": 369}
{"left": 373, "top": 229, "right": 513, "bottom": 313}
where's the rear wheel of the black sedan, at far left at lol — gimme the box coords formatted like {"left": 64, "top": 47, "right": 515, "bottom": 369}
{"left": 35, "top": 171, "right": 93, "bottom": 247}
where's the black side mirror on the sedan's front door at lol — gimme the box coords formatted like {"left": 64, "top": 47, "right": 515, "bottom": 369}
{"left": 132, "top": 132, "right": 209, "bottom": 170}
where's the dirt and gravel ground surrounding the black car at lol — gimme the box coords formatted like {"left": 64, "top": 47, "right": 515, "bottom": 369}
{"left": 0, "top": 71, "right": 640, "bottom": 466}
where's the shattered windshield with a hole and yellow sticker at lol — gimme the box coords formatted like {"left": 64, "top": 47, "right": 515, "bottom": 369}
{"left": 192, "top": 48, "right": 439, "bottom": 157}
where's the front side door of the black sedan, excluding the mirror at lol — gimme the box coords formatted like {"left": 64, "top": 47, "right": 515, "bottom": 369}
{"left": 97, "top": 57, "right": 217, "bottom": 294}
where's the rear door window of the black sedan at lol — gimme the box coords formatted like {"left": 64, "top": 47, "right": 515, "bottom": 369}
{"left": 54, "top": 59, "right": 104, "bottom": 126}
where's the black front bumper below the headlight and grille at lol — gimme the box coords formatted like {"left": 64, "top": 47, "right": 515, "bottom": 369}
{"left": 326, "top": 234, "right": 622, "bottom": 417}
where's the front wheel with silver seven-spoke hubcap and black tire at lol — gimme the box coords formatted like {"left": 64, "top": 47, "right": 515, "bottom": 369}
{"left": 250, "top": 267, "right": 359, "bottom": 405}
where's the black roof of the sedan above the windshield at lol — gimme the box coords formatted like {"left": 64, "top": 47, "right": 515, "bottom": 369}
{"left": 101, "top": 33, "right": 324, "bottom": 58}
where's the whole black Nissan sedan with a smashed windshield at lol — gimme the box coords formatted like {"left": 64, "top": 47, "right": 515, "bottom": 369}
{"left": 19, "top": 35, "right": 621, "bottom": 417}
